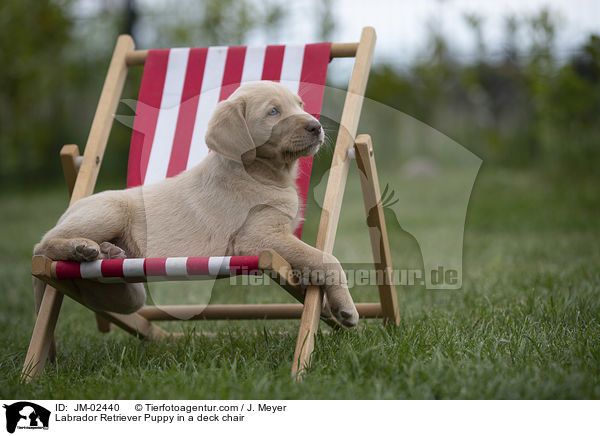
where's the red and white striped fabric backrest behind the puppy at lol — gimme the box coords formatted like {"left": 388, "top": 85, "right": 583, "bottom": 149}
{"left": 127, "top": 43, "right": 331, "bottom": 237}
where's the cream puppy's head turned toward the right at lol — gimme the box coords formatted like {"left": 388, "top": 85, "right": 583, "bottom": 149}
{"left": 206, "top": 81, "right": 324, "bottom": 164}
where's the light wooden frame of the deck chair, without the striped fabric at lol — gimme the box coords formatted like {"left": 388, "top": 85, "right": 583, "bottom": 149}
{"left": 21, "top": 27, "right": 399, "bottom": 382}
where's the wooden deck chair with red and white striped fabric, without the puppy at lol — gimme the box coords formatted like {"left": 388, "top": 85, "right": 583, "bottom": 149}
{"left": 22, "top": 27, "right": 399, "bottom": 382}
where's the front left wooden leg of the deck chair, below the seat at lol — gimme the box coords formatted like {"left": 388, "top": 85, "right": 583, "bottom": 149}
{"left": 21, "top": 286, "right": 63, "bottom": 383}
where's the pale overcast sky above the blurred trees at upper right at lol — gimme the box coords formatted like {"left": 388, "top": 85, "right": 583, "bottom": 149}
{"left": 270, "top": 0, "right": 600, "bottom": 64}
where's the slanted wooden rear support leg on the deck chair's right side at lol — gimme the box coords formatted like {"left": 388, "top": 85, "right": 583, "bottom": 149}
{"left": 354, "top": 135, "right": 400, "bottom": 325}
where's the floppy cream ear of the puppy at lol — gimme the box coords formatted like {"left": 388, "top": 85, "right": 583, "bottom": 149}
{"left": 205, "top": 97, "right": 256, "bottom": 163}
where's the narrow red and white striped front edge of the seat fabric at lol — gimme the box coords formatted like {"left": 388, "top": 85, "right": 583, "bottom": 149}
{"left": 56, "top": 256, "right": 260, "bottom": 282}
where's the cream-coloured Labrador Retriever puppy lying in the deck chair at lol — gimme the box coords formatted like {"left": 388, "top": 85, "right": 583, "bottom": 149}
{"left": 34, "top": 81, "right": 358, "bottom": 327}
